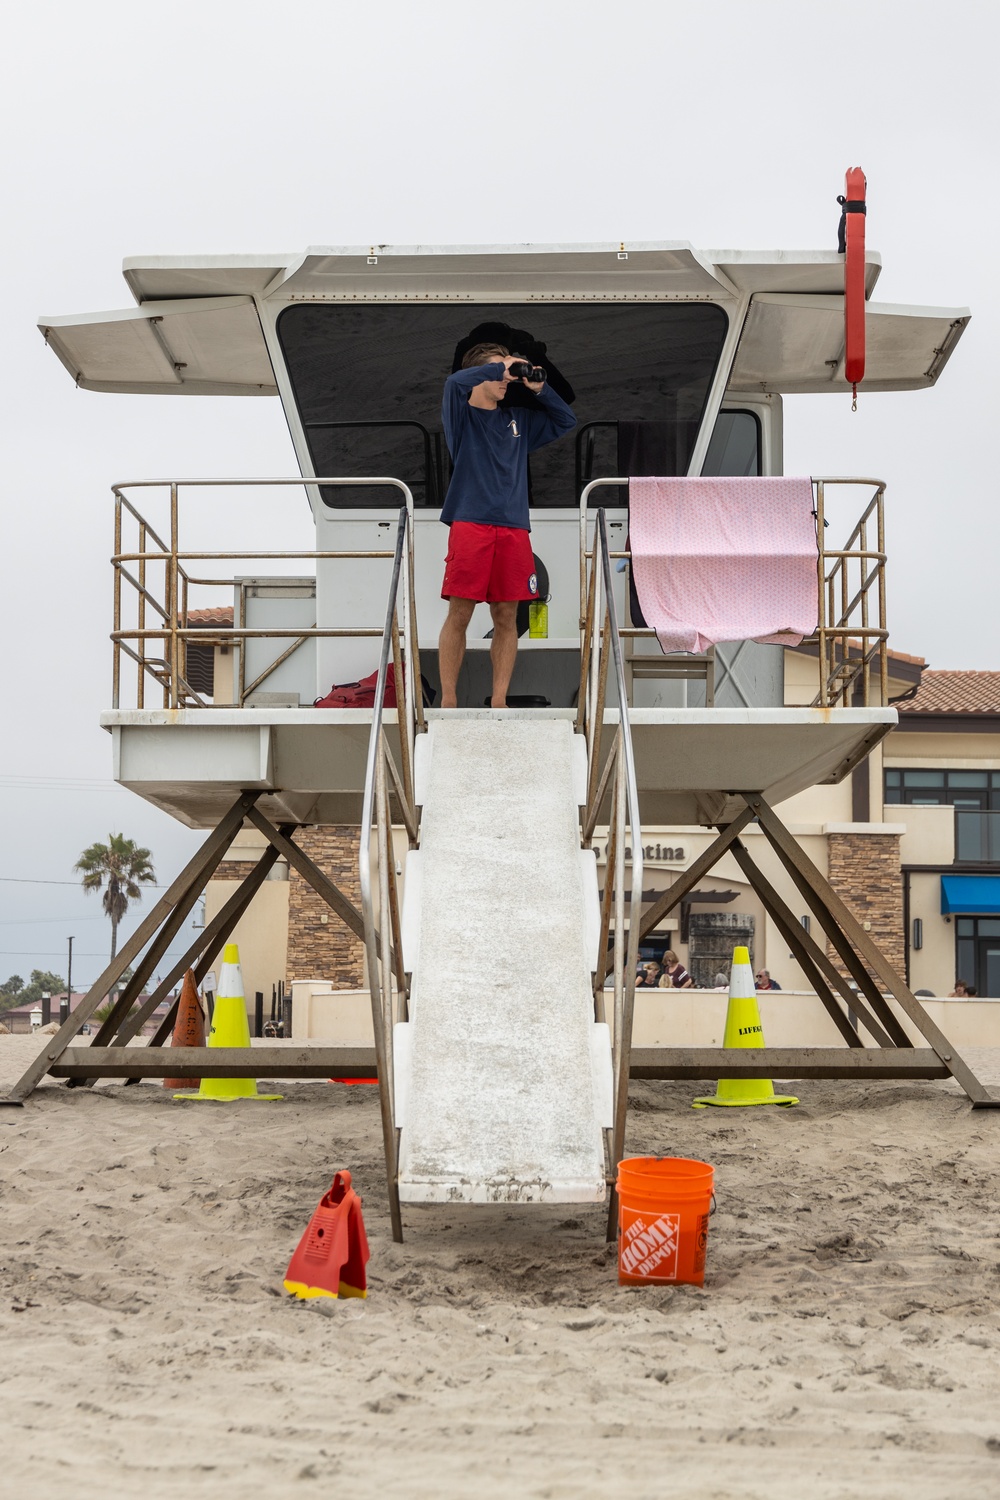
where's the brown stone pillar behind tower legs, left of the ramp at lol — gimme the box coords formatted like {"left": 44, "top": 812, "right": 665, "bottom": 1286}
{"left": 286, "top": 827, "right": 364, "bottom": 990}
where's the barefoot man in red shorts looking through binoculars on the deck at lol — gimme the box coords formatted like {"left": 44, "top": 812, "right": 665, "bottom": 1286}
{"left": 438, "top": 344, "right": 576, "bottom": 708}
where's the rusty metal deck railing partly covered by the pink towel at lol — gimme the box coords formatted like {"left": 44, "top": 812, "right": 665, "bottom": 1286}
{"left": 580, "top": 476, "right": 889, "bottom": 708}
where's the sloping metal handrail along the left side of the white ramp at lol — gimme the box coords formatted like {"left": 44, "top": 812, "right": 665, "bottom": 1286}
{"left": 358, "top": 509, "right": 426, "bottom": 1241}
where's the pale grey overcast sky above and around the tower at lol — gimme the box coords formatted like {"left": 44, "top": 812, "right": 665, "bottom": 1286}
{"left": 0, "top": 0, "right": 1000, "bottom": 981}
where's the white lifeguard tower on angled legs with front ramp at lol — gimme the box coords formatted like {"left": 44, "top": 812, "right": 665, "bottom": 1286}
{"left": 7, "top": 243, "right": 999, "bottom": 1238}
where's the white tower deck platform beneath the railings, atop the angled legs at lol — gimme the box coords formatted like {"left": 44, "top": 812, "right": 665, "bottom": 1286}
{"left": 100, "top": 708, "right": 897, "bottom": 828}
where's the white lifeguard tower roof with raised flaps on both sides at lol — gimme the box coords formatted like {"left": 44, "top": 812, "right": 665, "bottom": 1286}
{"left": 40, "top": 240, "right": 969, "bottom": 396}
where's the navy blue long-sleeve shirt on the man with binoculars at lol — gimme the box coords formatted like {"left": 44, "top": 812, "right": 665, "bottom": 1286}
{"left": 441, "top": 360, "right": 576, "bottom": 531}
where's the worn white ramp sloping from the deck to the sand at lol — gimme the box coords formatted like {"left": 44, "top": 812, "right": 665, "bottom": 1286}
{"left": 394, "top": 711, "right": 612, "bottom": 1203}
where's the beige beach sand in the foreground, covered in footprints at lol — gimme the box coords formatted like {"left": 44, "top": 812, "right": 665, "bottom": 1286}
{"left": 0, "top": 1037, "right": 1000, "bottom": 1500}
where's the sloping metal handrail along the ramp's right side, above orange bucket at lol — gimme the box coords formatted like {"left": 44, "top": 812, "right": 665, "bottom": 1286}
{"left": 577, "top": 509, "right": 643, "bottom": 1239}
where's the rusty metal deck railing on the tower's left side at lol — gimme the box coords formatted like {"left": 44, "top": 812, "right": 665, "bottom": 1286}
{"left": 111, "top": 476, "right": 423, "bottom": 708}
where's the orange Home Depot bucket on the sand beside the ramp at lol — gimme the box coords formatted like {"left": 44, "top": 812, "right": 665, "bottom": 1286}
{"left": 618, "top": 1157, "right": 715, "bottom": 1287}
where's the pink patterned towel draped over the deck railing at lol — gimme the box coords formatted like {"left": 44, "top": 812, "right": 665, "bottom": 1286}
{"left": 628, "top": 479, "right": 819, "bottom": 651}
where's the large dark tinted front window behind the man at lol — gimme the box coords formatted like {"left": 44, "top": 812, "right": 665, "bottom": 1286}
{"left": 277, "top": 303, "right": 731, "bottom": 506}
